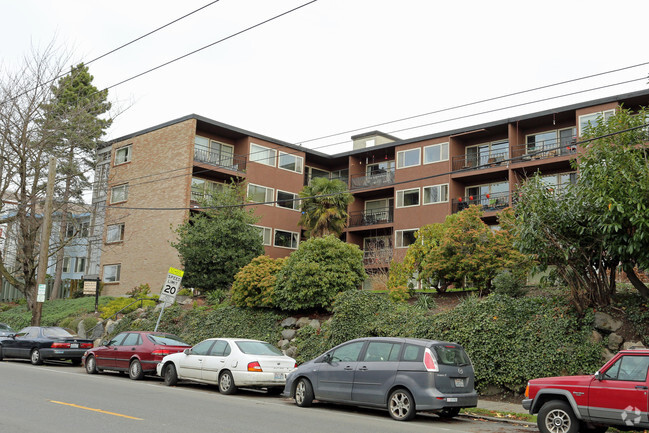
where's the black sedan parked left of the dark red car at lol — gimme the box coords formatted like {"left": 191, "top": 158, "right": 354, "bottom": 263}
{"left": 0, "top": 326, "right": 92, "bottom": 365}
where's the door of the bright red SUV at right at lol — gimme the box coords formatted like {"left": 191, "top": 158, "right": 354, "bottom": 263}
{"left": 588, "top": 354, "right": 649, "bottom": 427}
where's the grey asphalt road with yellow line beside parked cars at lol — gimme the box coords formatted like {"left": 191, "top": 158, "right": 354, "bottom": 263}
{"left": 0, "top": 360, "right": 537, "bottom": 433}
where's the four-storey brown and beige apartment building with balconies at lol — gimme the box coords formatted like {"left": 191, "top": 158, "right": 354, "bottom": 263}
{"left": 90, "top": 91, "right": 649, "bottom": 295}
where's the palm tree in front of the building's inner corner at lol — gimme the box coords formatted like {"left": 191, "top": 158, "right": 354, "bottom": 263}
{"left": 299, "top": 177, "right": 354, "bottom": 237}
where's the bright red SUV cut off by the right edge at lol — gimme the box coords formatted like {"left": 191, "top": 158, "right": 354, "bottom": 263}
{"left": 523, "top": 349, "right": 649, "bottom": 433}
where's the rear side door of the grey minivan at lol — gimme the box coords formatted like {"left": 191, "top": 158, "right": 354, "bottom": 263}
{"left": 352, "top": 341, "right": 402, "bottom": 405}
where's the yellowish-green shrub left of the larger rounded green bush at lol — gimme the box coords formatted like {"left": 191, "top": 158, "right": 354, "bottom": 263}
{"left": 231, "top": 255, "right": 284, "bottom": 307}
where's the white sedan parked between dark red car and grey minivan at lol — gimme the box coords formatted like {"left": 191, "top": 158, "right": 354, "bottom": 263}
{"left": 157, "top": 338, "right": 297, "bottom": 394}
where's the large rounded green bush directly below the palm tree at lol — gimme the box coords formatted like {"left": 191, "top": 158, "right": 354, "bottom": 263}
{"left": 273, "top": 235, "right": 367, "bottom": 311}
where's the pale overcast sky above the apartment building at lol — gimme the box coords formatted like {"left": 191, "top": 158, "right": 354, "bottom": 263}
{"left": 0, "top": 0, "right": 649, "bottom": 153}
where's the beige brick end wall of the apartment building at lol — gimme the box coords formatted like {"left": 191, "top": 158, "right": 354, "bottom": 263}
{"left": 101, "top": 119, "right": 196, "bottom": 296}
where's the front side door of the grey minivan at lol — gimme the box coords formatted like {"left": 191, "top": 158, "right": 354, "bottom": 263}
{"left": 313, "top": 341, "right": 365, "bottom": 401}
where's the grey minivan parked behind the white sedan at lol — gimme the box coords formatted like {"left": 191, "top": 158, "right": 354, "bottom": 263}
{"left": 283, "top": 337, "right": 478, "bottom": 421}
